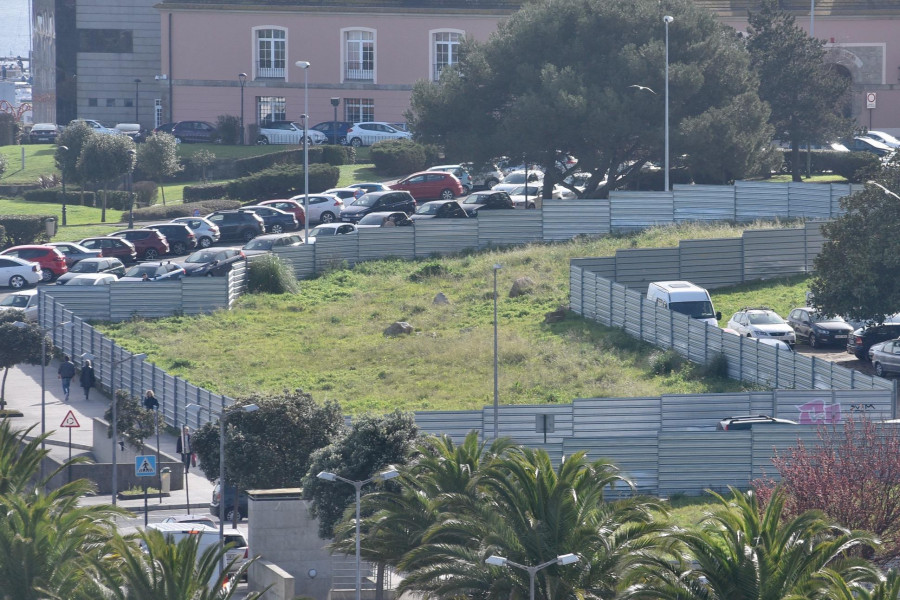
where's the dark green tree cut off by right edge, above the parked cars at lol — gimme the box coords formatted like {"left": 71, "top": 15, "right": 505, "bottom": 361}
{"left": 810, "top": 161, "right": 900, "bottom": 322}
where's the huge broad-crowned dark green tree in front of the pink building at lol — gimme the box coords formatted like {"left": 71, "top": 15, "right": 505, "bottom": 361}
{"left": 407, "top": 0, "right": 771, "bottom": 197}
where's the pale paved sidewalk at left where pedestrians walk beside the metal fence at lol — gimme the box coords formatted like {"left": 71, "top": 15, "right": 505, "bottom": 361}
{"left": 6, "top": 360, "right": 214, "bottom": 514}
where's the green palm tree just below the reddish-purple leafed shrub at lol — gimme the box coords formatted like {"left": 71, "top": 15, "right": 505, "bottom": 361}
{"left": 622, "top": 489, "right": 877, "bottom": 600}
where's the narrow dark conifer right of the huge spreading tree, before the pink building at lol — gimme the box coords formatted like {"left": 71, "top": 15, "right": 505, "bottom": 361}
{"left": 747, "top": 0, "right": 852, "bottom": 181}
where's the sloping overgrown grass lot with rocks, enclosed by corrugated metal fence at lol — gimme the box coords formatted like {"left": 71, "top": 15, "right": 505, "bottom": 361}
{"left": 100, "top": 223, "right": 800, "bottom": 413}
